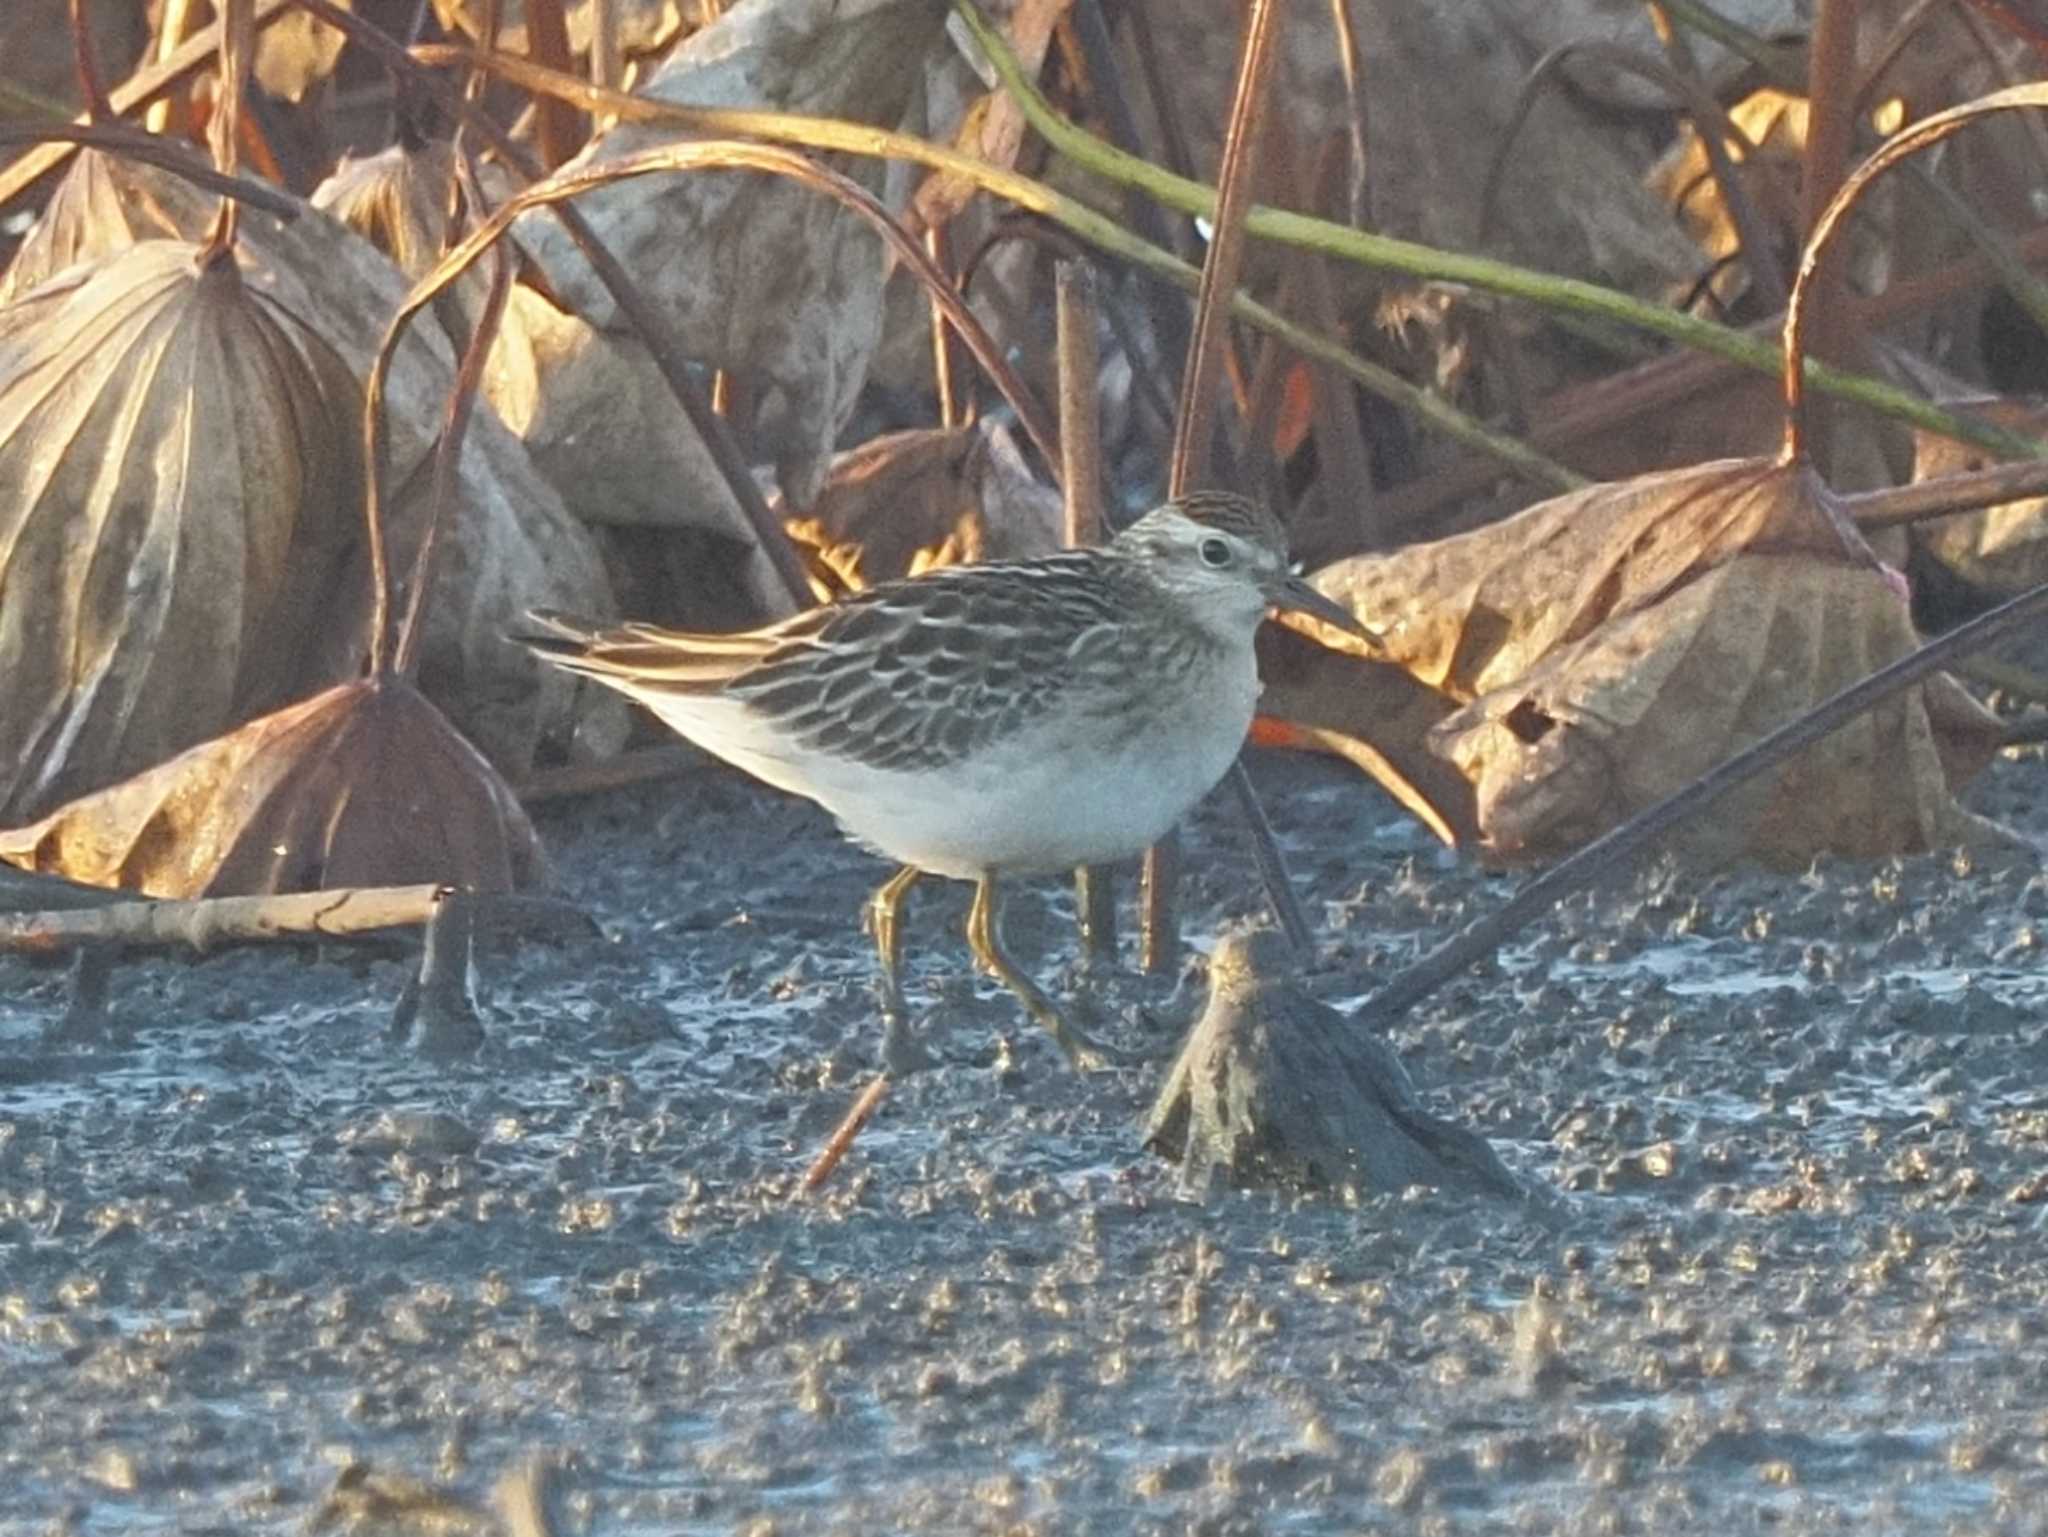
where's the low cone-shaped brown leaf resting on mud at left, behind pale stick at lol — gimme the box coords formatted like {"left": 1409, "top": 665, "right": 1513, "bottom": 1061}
{"left": 0, "top": 680, "right": 541, "bottom": 898}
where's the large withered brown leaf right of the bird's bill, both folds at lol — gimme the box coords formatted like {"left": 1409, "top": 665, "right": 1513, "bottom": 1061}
{"left": 1266, "top": 459, "right": 1999, "bottom": 865}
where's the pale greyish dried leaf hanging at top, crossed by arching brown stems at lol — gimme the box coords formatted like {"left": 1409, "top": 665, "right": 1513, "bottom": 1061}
{"left": 518, "top": 0, "right": 946, "bottom": 506}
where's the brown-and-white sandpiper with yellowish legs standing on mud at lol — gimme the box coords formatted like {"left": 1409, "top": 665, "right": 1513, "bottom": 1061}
{"left": 518, "top": 492, "right": 1366, "bottom": 1072}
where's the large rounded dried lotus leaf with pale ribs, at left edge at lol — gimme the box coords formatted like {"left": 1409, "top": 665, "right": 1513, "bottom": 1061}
{"left": 0, "top": 240, "right": 360, "bottom": 818}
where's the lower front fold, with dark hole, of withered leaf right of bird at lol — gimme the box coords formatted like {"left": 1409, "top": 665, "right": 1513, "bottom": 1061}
{"left": 1438, "top": 555, "right": 2011, "bottom": 867}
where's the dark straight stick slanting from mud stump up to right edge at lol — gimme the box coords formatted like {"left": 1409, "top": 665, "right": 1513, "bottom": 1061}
{"left": 1352, "top": 582, "right": 2048, "bottom": 1029}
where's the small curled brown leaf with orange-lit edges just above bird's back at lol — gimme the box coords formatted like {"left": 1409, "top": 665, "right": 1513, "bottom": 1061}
{"left": 786, "top": 422, "right": 1061, "bottom": 596}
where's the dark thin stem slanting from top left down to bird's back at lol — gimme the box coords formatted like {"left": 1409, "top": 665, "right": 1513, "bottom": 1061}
{"left": 294, "top": 0, "right": 811, "bottom": 609}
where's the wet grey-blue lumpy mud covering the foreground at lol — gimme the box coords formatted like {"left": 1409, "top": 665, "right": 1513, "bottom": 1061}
{"left": 0, "top": 754, "right": 2048, "bottom": 1537}
